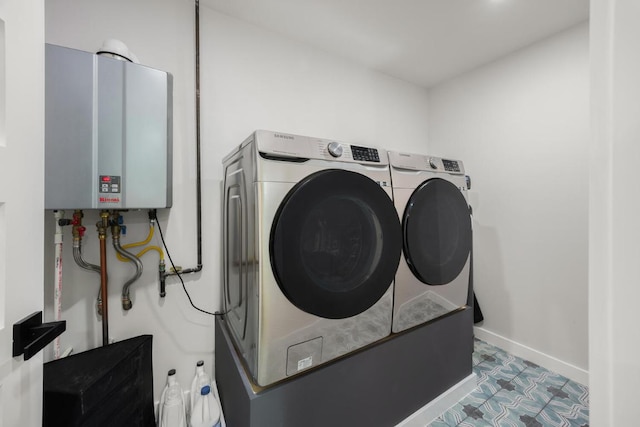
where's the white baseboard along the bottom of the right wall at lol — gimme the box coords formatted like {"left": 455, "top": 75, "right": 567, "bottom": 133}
{"left": 473, "top": 326, "right": 589, "bottom": 385}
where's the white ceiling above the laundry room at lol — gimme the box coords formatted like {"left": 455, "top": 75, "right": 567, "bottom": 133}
{"left": 200, "top": 0, "right": 589, "bottom": 87}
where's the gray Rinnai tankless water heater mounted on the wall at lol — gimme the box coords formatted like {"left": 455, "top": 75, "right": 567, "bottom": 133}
{"left": 45, "top": 44, "right": 173, "bottom": 209}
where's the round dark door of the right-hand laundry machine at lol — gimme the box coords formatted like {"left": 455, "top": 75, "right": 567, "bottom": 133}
{"left": 402, "top": 178, "right": 471, "bottom": 285}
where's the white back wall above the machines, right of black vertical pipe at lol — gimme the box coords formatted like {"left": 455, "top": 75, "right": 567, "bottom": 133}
{"left": 201, "top": 8, "right": 427, "bottom": 171}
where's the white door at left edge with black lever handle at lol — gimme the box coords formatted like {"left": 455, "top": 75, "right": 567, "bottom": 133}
{"left": 0, "top": 0, "right": 44, "bottom": 426}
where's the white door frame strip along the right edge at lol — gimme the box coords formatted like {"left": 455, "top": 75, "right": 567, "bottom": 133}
{"left": 589, "top": 0, "right": 640, "bottom": 427}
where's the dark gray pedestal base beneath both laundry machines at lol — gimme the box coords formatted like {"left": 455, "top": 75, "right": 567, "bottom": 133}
{"left": 215, "top": 308, "right": 473, "bottom": 427}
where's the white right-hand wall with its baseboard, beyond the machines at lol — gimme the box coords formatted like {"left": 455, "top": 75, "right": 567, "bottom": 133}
{"left": 429, "top": 23, "right": 590, "bottom": 384}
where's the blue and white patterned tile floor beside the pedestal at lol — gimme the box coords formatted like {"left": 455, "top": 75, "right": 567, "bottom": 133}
{"left": 429, "top": 339, "right": 589, "bottom": 427}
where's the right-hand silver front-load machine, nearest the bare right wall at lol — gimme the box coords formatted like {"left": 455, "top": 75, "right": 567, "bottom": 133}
{"left": 389, "top": 151, "right": 471, "bottom": 332}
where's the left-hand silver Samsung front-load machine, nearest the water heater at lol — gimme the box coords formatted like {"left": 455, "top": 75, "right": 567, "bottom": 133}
{"left": 223, "top": 131, "right": 402, "bottom": 386}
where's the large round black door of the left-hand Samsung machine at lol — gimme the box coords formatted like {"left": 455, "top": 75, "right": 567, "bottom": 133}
{"left": 269, "top": 169, "right": 402, "bottom": 319}
